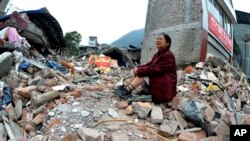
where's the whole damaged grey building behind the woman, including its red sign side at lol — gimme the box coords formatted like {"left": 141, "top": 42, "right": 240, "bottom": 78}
{"left": 141, "top": 0, "right": 236, "bottom": 65}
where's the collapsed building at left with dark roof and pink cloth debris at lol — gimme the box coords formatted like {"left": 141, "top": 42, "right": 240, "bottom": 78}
{"left": 0, "top": 8, "right": 65, "bottom": 79}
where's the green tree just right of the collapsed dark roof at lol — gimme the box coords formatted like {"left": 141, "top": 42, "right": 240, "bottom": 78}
{"left": 64, "top": 31, "right": 82, "bottom": 56}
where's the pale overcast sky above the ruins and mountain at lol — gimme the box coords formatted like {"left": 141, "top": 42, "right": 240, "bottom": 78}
{"left": 8, "top": 0, "right": 250, "bottom": 44}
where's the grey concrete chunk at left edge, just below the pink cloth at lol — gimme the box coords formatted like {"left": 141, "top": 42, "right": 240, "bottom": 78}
{"left": 0, "top": 52, "right": 12, "bottom": 78}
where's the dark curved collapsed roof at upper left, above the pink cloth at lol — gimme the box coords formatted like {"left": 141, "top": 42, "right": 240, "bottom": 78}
{"left": 0, "top": 8, "right": 65, "bottom": 49}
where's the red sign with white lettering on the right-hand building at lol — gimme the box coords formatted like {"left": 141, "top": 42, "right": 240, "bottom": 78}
{"left": 208, "top": 13, "right": 233, "bottom": 53}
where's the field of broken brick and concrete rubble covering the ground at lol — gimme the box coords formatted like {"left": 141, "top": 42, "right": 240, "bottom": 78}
{"left": 0, "top": 42, "right": 250, "bottom": 141}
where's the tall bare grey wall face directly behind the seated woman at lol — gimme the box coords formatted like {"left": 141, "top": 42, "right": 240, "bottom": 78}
{"left": 141, "top": 0, "right": 202, "bottom": 64}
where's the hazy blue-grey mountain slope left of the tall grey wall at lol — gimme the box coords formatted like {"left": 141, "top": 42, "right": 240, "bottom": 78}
{"left": 111, "top": 28, "right": 144, "bottom": 48}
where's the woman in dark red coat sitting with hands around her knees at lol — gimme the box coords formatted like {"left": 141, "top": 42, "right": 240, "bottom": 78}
{"left": 115, "top": 33, "right": 177, "bottom": 103}
